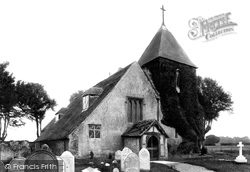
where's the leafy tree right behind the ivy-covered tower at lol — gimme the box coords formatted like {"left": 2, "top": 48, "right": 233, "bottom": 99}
{"left": 197, "top": 76, "right": 233, "bottom": 135}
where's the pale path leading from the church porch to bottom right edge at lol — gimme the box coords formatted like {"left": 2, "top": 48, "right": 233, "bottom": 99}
{"left": 151, "top": 161, "right": 214, "bottom": 172}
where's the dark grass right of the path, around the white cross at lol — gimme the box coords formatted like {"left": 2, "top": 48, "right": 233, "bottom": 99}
{"left": 183, "top": 151, "right": 250, "bottom": 172}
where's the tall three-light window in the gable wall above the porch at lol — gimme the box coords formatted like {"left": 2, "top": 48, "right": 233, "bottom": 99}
{"left": 127, "top": 97, "right": 143, "bottom": 122}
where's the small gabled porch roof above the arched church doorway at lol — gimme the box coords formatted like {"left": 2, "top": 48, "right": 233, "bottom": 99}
{"left": 122, "top": 119, "right": 168, "bottom": 137}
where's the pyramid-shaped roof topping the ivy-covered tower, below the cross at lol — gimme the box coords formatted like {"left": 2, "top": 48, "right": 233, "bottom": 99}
{"left": 138, "top": 25, "right": 196, "bottom": 68}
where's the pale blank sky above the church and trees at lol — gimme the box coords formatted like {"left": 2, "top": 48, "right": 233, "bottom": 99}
{"left": 0, "top": 0, "right": 250, "bottom": 141}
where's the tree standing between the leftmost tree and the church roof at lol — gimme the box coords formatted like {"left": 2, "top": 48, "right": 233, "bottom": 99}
{"left": 16, "top": 81, "right": 56, "bottom": 137}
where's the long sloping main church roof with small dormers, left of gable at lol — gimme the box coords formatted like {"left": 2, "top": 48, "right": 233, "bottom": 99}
{"left": 35, "top": 64, "right": 131, "bottom": 142}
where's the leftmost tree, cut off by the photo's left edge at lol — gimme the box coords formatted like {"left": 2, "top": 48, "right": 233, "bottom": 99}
{"left": 0, "top": 62, "right": 25, "bottom": 142}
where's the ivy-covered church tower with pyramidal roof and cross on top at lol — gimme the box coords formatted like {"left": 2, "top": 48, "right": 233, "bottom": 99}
{"left": 138, "top": 6, "right": 200, "bottom": 141}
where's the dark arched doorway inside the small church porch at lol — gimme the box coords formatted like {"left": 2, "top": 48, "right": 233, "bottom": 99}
{"left": 147, "top": 136, "right": 159, "bottom": 159}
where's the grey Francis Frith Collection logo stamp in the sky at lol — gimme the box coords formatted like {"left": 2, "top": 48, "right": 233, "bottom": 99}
{"left": 188, "top": 12, "right": 237, "bottom": 41}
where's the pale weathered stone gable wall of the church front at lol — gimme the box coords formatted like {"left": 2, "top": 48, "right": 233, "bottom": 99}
{"left": 69, "top": 62, "right": 161, "bottom": 157}
